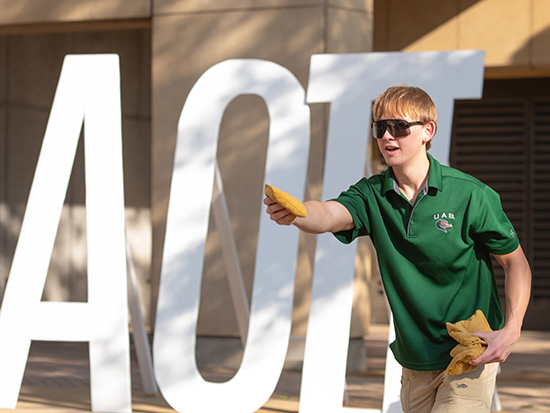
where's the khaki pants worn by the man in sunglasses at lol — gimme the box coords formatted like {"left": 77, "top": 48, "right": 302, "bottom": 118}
{"left": 401, "top": 363, "right": 498, "bottom": 413}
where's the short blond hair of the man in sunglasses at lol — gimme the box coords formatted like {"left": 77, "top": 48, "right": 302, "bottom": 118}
{"left": 372, "top": 85, "right": 437, "bottom": 150}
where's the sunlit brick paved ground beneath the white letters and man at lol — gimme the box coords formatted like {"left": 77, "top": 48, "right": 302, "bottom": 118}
{"left": 0, "top": 327, "right": 550, "bottom": 413}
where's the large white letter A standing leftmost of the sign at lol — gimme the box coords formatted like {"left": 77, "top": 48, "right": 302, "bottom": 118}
{"left": 0, "top": 55, "right": 131, "bottom": 412}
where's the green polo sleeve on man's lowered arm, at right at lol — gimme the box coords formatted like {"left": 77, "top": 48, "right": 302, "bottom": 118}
{"left": 473, "top": 186, "right": 519, "bottom": 254}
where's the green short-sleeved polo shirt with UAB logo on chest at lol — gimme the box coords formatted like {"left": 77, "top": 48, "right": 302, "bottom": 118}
{"left": 334, "top": 155, "right": 519, "bottom": 370}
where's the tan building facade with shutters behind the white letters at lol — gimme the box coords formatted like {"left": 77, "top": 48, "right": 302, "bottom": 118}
{"left": 0, "top": 0, "right": 550, "bottom": 368}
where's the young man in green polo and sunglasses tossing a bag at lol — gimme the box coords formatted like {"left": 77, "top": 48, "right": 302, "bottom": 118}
{"left": 264, "top": 86, "right": 531, "bottom": 413}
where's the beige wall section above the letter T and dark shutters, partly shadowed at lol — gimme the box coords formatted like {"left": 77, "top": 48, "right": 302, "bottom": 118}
{"left": 374, "top": 0, "right": 550, "bottom": 77}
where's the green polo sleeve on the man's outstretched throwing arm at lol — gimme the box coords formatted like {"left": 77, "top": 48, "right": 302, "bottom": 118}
{"left": 332, "top": 179, "right": 370, "bottom": 244}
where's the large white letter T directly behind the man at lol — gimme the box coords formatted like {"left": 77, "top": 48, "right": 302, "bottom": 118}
{"left": 300, "top": 51, "right": 483, "bottom": 413}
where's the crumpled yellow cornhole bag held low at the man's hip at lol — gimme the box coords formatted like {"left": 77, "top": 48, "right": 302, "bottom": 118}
{"left": 445, "top": 310, "right": 492, "bottom": 375}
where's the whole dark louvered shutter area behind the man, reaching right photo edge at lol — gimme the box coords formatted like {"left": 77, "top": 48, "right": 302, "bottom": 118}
{"left": 451, "top": 96, "right": 550, "bottom": 329}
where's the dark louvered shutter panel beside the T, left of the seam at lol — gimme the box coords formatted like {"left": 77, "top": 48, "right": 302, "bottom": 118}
{"left": 451, "top": 99, "right": 529, "bottom": 296}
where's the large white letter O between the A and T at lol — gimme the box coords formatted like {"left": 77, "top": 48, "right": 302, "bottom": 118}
{"left": 153, "top": 60, "right": 309, "bottom": 413}
